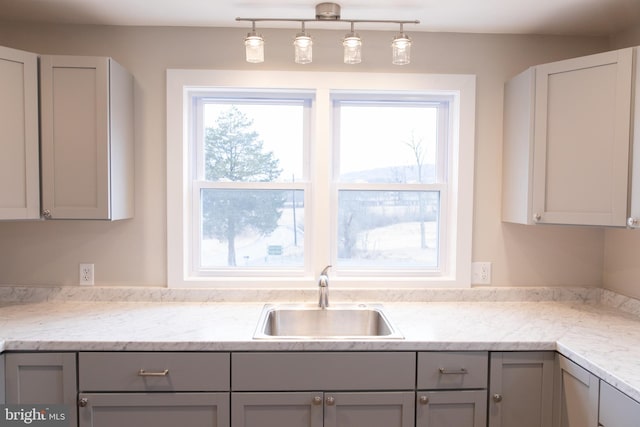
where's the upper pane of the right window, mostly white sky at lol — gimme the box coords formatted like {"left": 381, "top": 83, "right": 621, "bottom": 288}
{"left": 339, "top": 103, "right": 438, "bottom": 183}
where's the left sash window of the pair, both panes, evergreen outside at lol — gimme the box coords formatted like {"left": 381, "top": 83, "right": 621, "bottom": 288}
{"left": 188, "top": 95, "right": 311, "bottom": 276}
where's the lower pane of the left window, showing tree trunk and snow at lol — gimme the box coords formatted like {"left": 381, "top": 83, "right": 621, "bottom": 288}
{"left": 200, "top": 189, "right": 304, "bottom": 268}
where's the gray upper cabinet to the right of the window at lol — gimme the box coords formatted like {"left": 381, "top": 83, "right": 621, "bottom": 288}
{"left": 502, "top": 48, "right": 640, "bottom": 227}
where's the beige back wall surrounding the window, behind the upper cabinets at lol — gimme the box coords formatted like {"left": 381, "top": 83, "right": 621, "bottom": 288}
{"left": 0, "top": 23, "right": 612, "bottom": 286}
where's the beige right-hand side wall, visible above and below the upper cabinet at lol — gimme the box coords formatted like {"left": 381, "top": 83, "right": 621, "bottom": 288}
{"left": 603, "top": 26, "right": 640, "bottom": 298}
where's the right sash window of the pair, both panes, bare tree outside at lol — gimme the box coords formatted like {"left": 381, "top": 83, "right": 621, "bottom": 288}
{"left": 332, "top": 92, "right": 452, "bottom": 275}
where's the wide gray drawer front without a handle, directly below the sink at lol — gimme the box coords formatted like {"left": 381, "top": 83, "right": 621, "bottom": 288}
{"left": 231, "top": 352, "right": 416, "bottom": 391}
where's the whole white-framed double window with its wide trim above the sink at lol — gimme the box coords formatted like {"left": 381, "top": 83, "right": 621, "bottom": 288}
{"left": 167, "top": 70, "right": 475, "bottom": 287}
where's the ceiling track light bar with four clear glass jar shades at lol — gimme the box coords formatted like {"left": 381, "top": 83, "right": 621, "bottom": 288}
{"left": 236, "top": 2, "right": 420, "bottom": 65}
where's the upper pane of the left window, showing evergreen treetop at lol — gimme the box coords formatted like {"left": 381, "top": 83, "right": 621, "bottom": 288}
{"left": 203, "top": 105, "right": 305, "bottom": 182}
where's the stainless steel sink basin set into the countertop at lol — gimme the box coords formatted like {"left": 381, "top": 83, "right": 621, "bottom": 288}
{"left": 253, "top": 304, "right": 404, "bottom": 340}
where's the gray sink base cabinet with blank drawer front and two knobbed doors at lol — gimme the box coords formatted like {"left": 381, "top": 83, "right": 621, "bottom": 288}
{"left": 231, "top": 352, "right": 416, "bottom": 427}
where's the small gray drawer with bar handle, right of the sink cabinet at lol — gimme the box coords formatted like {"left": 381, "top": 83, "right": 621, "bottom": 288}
{"left": 418, "top": 351, "right": 489, "bottom": 390}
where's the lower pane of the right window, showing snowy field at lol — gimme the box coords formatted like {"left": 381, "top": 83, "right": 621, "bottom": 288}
{"left": 338, "top": 190, "right": 440, "bottom": 268}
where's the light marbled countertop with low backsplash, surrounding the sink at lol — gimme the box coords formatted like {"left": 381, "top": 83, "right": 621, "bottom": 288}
{"left": 0, "top": 288, "right": 640, "bottom": 401}
